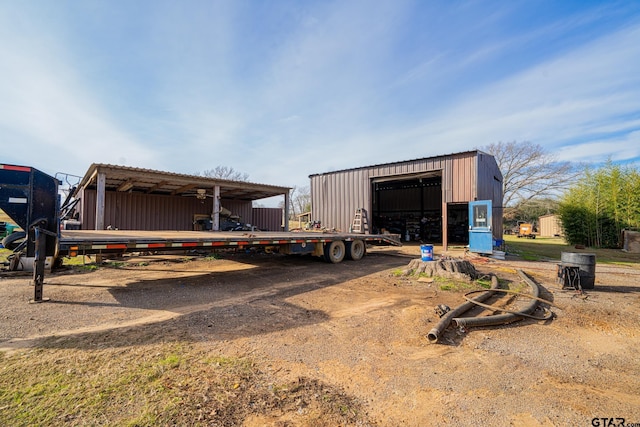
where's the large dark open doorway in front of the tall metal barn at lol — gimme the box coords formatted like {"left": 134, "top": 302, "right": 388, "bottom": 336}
{"left": 372, "top": 173, "right": 442, "bottom": 243}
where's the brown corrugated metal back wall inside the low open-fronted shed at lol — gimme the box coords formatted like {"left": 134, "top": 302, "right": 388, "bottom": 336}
{"left": 81, "top": 190, "right": 253, "bottom": 230}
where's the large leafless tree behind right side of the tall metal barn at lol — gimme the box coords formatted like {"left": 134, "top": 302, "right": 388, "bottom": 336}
{"left": 480, "top": 141, "right": 580, "bottom": 208}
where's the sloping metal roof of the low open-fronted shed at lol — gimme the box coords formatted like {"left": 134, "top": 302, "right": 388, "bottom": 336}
{"left": 76, "top": 163, "right": 291, "bottom": 201}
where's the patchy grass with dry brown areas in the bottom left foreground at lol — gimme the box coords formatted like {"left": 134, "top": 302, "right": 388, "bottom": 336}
{"left": 0, "top": 335, "right": 369, "bottom": 426}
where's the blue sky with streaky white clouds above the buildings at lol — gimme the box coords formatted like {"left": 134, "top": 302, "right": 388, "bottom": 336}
{"left": 0, "top": 0, "right": 640, "bottom": 196}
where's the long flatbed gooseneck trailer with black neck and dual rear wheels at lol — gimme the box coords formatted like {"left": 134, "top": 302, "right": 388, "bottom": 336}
{"left": 0, "top": 164, "right": 401, "bottom": 302}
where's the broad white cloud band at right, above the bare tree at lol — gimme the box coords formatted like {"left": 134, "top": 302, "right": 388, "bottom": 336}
{"left": 390, "top": 19, "right": 640, "bottom": 162}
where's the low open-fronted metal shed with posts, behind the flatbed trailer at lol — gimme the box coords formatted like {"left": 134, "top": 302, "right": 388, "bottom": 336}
{"left": 71, "top": 163, "right": 290, "bottom": 231}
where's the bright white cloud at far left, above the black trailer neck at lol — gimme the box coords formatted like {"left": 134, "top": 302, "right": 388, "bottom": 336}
{"left": 0, "top": 3, "right": 154, "bottom": 173}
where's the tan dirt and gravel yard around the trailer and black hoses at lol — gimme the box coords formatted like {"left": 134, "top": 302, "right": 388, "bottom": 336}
{"left": 0, "top": 246, "right": 640, "bottom": 426}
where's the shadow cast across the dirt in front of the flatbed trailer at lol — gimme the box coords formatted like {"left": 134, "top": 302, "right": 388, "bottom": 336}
{"left": 30, "top": 254, "right": 406, "bottom": 349}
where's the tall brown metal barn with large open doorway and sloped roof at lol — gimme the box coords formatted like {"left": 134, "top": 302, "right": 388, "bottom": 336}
{"left": 309, "top": 150, "right": 502, "bottom": 250}
